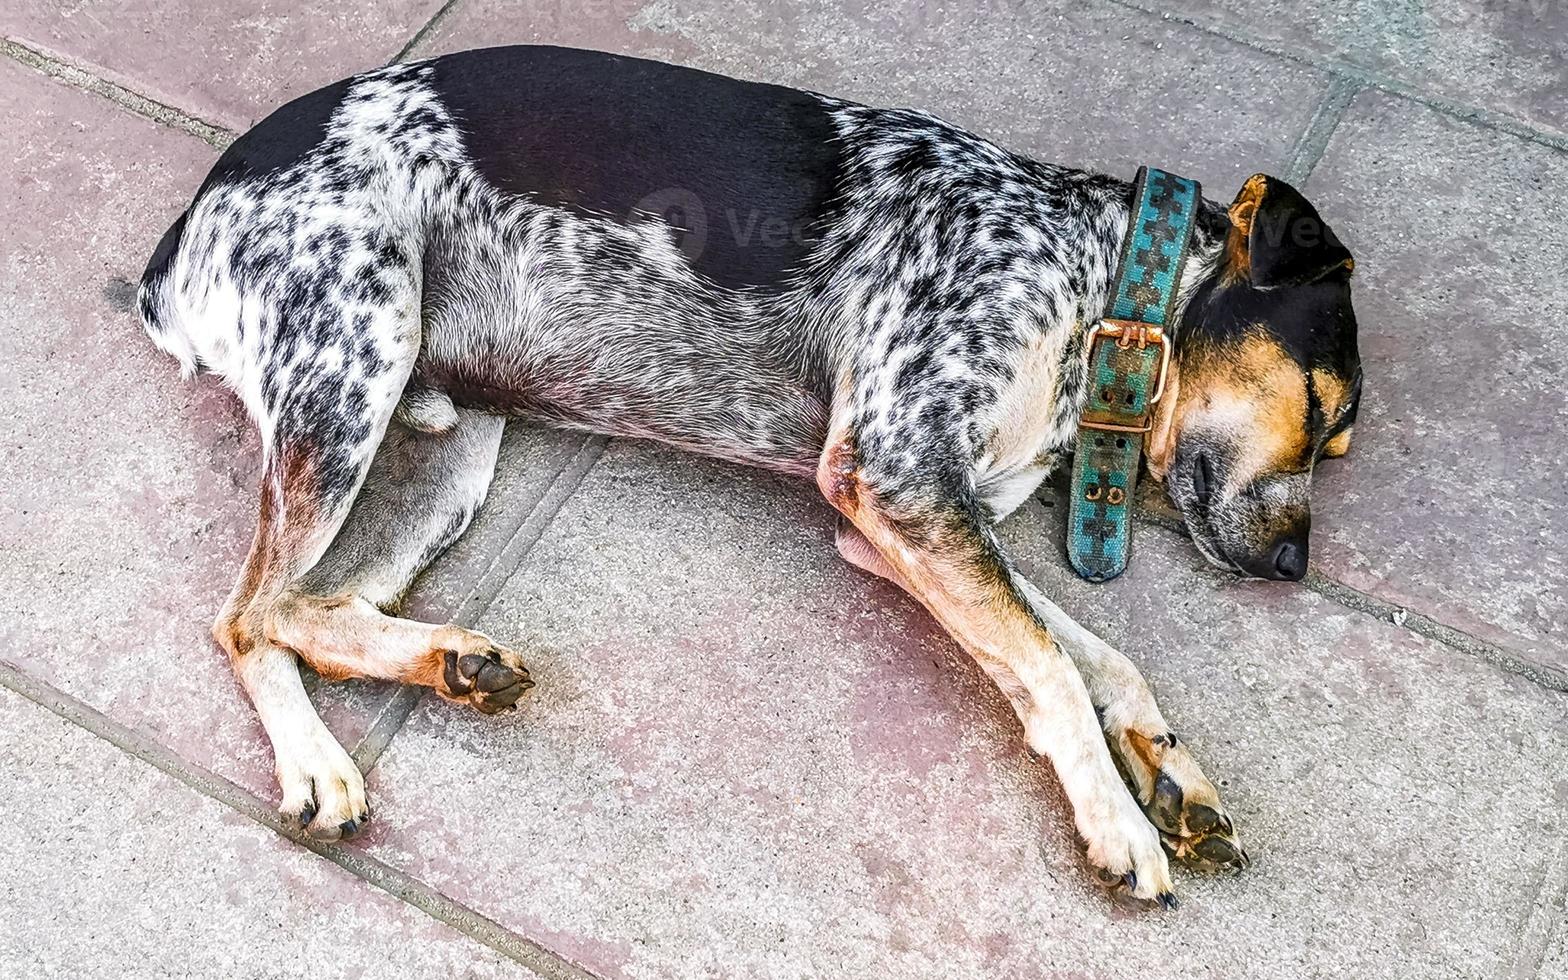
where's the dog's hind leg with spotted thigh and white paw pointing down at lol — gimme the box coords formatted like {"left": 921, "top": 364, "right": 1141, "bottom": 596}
{"left": 213, "top": 292, "right": 420, "bottom": 839}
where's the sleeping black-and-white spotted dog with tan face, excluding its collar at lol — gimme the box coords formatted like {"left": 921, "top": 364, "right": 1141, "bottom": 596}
{"left": 140, "top": 47, "right": 1359, "bottom": 905}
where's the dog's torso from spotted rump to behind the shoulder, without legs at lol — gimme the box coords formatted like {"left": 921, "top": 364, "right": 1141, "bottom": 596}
{"left": 141, "top": 47, "right": 884, "bottom": 472}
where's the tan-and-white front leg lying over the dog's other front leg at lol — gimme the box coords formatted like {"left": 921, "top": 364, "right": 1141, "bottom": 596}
{"left": 817, "top": 434, "right": 1174, "bottom": 905}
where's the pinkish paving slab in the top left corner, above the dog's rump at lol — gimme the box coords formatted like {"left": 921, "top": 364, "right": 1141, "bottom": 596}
{"left": 0, "top": 0, "right": 441, "bottom": 130}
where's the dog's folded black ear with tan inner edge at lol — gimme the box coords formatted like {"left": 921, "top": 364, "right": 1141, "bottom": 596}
{"left": 1226, "top": 174, "right": 1355, "bottom": 289}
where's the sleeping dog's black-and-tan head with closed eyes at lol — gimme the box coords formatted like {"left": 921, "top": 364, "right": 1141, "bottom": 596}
{"left": 1149, "top": 174, "right": 1361, "bottom": 580}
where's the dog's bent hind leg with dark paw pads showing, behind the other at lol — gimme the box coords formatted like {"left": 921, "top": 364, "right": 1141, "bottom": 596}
{"left": 268, "top": 411, "right": 533, "bottom": 713}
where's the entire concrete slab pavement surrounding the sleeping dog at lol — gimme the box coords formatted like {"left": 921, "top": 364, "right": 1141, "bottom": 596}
{"left": 0, "top": 0, "right": 1568, "bottom": 980}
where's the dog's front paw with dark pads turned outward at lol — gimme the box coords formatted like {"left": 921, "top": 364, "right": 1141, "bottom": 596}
{"left": 1126, "top": 732, "right": 1251, "bottom": 872}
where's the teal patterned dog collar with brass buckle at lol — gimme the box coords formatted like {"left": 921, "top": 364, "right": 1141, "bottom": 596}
{"left": 1068, "top": 166, "right": 1203, "bottom": 582}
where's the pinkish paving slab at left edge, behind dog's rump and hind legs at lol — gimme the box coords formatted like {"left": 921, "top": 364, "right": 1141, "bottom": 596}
{"left": 0, "top": 63, "right": 390, "bottom": 797}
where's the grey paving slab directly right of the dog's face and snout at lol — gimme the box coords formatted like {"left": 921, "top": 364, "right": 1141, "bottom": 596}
{"left": 1308, "top": 93, "right": 1568, "bottom": 668}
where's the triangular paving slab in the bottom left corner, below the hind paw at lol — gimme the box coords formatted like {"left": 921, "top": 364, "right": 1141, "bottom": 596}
{"left": 0, "top": 690, "right": 533, "bottom": 980}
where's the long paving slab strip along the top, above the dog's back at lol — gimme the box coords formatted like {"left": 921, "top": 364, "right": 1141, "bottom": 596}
{"left": 414, "top": 0, "right": 1328, "bottom": 199}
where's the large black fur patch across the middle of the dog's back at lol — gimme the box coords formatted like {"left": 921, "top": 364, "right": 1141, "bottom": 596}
{"left": 431, "top": 47, "right": 840, "bottom": 289}
